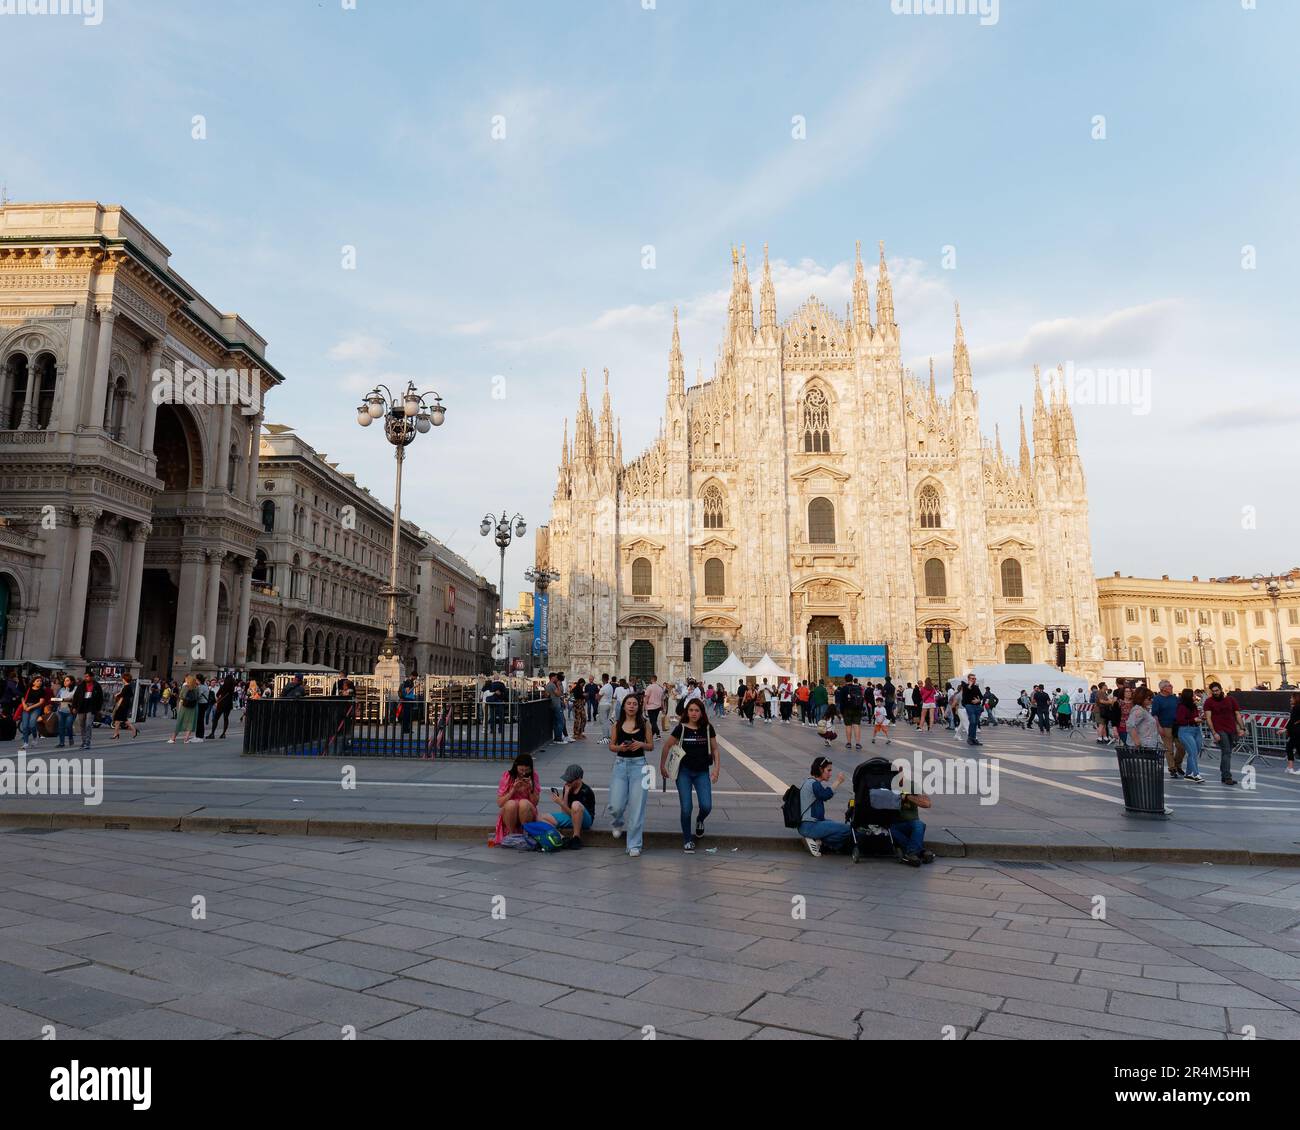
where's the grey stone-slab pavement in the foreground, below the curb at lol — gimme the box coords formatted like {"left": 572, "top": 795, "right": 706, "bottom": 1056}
{"left": 0, "top": 828, "right": 1300, "bottom": 1040}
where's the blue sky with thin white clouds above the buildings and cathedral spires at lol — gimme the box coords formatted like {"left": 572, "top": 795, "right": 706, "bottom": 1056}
{"left": 0, "top": 0, "right": 1300, "bottom": 605}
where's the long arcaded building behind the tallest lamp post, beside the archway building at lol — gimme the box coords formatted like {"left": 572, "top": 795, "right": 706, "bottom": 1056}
{"left": 247, "top": 424, "right": 425, "bottom": 675}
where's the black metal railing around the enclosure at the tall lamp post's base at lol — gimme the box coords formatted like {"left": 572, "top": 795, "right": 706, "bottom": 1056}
{"left": 243, "top": 696, "right": 551, "bottom": 761}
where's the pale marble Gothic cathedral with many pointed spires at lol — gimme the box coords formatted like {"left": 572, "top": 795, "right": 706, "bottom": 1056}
{"left": 538, "top": 246, "right": 1102, "bottom": 679}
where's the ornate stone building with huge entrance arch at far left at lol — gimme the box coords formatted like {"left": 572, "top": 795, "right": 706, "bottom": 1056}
{"left": 0, "top": 203, "right": 274, "bottom": 675}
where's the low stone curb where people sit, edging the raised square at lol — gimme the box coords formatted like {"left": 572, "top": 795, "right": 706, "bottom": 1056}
{"left": 0, "top": 810, "right": 1300, "bottom": 867}
